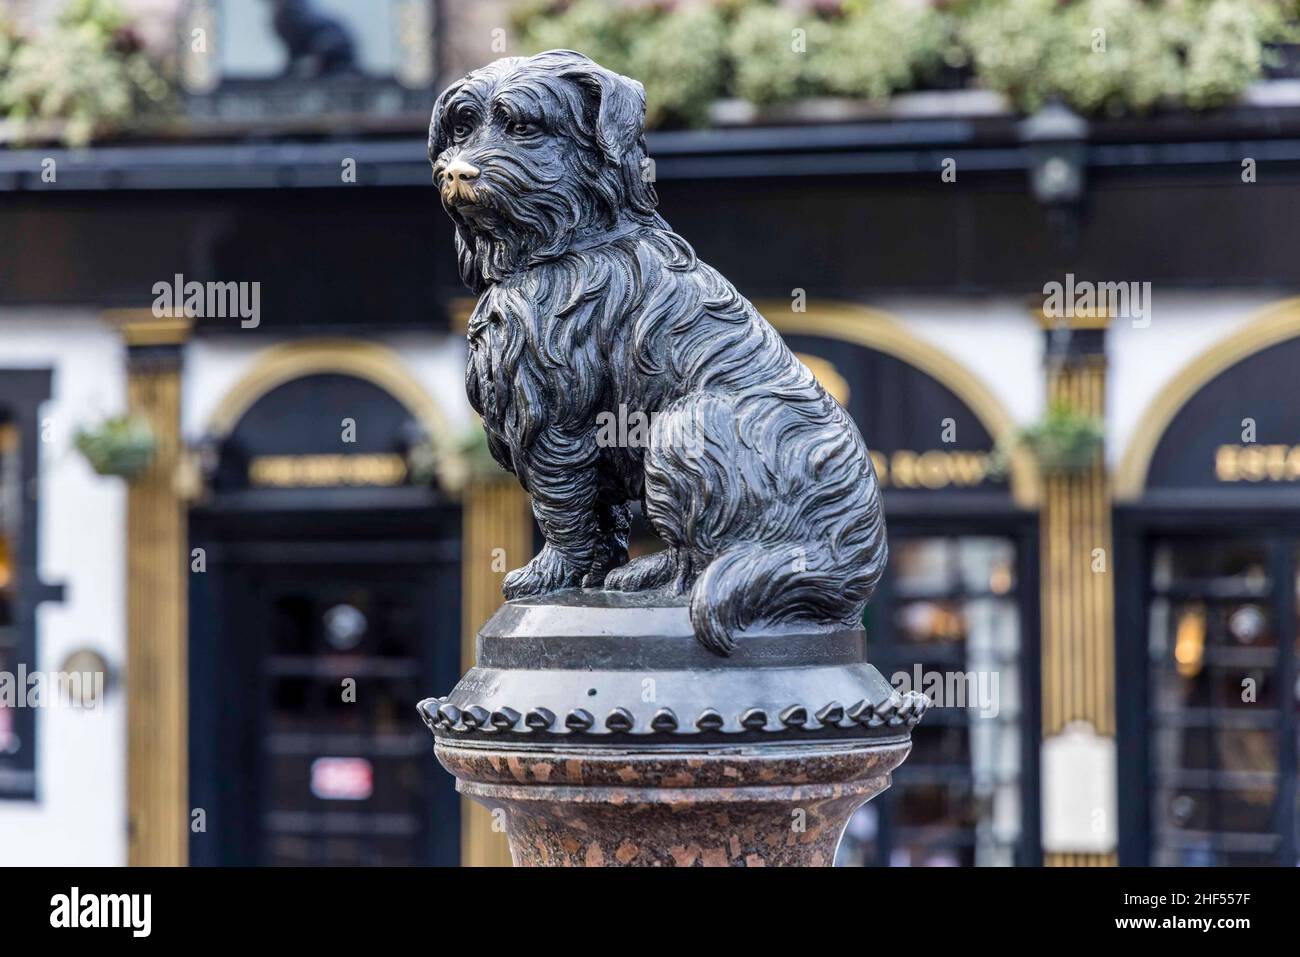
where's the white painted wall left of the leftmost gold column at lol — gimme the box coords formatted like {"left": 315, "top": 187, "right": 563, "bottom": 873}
{"left": 0, "top": 308, "right": 126, "bottom": 865}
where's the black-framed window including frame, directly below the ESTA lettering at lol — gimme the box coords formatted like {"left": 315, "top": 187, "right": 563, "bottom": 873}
{"left": 1115, "top": 509, "right": 1300, "bottom": 866}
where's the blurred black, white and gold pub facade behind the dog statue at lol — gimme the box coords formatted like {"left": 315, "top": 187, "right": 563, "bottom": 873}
{"left": 0, "top": 4, "right": 1300, "bottom": 866}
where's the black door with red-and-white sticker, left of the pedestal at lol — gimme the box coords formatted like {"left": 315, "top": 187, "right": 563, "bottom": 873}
{"left": 190, "top": 501, "right": 460, "bottom": 866}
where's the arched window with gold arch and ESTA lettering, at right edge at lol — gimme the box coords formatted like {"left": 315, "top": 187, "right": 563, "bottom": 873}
{"left": 1115, "top": 300, "right": 1300, "bottom": 866}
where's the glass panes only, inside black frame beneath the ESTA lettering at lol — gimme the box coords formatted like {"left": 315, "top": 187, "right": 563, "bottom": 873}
{"left": 1148, "top": 537, "right": 1292, "bottom": 866}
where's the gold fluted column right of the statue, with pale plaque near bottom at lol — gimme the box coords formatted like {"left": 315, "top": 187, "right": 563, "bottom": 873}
{"left": 1040, "top": 316, "right": 1118, "bottom": 867}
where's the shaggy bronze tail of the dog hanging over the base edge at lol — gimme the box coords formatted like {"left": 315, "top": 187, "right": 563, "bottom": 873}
{"left": 690, "top": 529, "right": 885, "bottom": 655}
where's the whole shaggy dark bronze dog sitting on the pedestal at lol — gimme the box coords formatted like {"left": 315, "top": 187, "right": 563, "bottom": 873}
{"left": 429, "top": 51, "right": 885, "bottom": 654}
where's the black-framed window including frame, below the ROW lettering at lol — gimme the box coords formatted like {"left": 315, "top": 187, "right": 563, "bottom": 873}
{"left": 837, "top": 504, "right": 1041, "bottom": 866}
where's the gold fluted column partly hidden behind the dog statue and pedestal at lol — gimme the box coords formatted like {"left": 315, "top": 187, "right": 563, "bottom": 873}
{"left": 460, "top": 475, "right": 533, "bottom": 867}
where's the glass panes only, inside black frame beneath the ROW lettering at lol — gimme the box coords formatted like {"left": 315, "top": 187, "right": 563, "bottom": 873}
{"left": 837, "top": 531, "right": 1037, "bottom": 866}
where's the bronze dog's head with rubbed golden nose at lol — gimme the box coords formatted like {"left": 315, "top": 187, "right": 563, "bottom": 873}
{"left": 429, "top": 49, "right": 658, "bottom": 290}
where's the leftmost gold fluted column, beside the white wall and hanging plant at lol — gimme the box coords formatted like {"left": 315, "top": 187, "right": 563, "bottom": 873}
{"left": 109, "top": 309, "right": 190, "bottom": 866}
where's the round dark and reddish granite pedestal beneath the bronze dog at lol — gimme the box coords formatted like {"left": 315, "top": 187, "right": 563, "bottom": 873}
{"left": 420, "top": 590, "right": 928, "bottom": 866}
